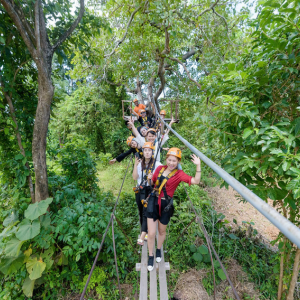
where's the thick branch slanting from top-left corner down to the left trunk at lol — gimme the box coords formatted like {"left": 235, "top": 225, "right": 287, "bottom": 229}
{"left": 0, "top": 0, "right": 36, "bottom": 59}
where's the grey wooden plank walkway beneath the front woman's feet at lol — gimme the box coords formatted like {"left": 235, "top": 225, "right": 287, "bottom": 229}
{"left": 136, "top": 236, "right": 170, "bottom": 300}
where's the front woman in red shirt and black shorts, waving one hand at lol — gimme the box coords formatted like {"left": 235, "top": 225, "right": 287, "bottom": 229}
{"left": 146, "top": 148, "right": 201, "bottom": 271}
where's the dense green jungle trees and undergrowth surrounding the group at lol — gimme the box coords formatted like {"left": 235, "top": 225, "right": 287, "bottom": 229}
{"left": 0, "top": 0, "right": 300, "bottom": 300}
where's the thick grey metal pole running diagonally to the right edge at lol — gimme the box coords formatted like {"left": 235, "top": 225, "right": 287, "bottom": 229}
{"left": 154, "top": 103, "right": 300, "bottom": 248}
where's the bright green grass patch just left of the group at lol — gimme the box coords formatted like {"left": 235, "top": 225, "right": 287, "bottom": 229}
{"left": 97, "top": 158, "right": 136, "bottom": 196}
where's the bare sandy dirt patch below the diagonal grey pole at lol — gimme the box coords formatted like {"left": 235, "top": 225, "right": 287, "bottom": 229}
{"left": 205, "top": 187, "right": 279, "bottom": 241}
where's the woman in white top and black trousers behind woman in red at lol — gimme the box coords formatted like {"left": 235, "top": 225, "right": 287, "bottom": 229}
{"left": 132, "top": 142, "right": 161, "bottom": 245}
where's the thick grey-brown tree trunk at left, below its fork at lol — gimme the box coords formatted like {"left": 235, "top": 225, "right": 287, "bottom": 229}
{"left": 32, "top": 74, "right": 54, "bottom": 202}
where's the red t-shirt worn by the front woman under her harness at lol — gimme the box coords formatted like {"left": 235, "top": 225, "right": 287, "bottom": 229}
{"left": 152, "top": 166, "right": 193, "bottom": 215}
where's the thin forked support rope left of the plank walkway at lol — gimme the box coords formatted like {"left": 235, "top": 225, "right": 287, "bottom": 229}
{"left": 80, "top": 155, "right": 133, "bottom": 300}
